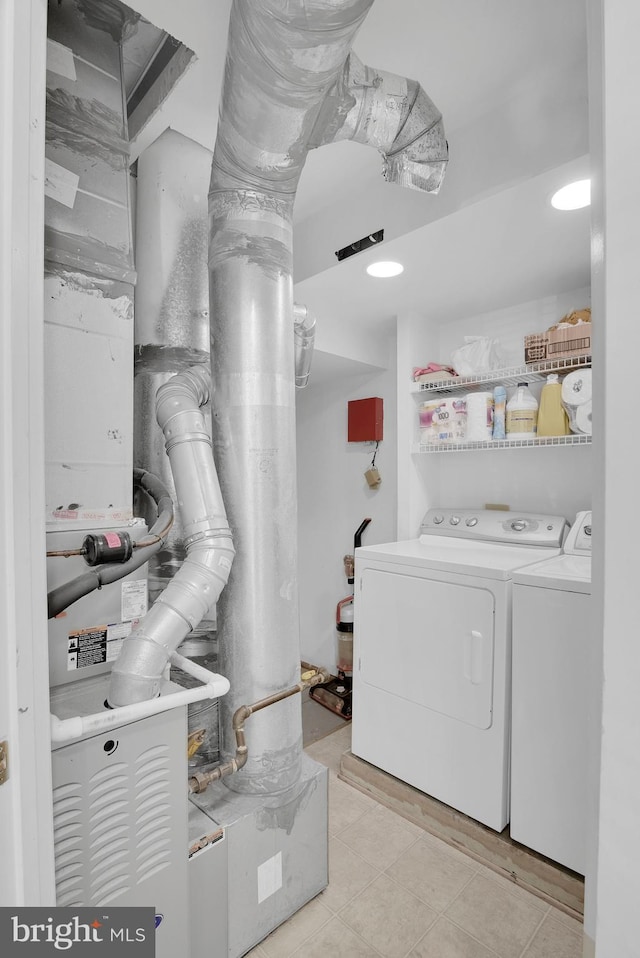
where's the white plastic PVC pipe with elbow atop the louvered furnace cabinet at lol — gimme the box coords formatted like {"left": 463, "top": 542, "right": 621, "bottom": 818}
{"left": 51, "top": 652, "right": 229, "bottom": 742}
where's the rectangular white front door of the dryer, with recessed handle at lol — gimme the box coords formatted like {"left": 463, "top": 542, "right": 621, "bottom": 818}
{"left": 355, "top": 569, "right": 495, "bottom": 729}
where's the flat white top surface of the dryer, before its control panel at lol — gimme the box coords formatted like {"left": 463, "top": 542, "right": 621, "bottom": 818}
{"left": 355, "top": 535, "right": 560, "bottom": 579}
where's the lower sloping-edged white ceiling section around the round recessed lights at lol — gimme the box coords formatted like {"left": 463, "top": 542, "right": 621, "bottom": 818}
{"left": 296, "top": 157, "right": 590, "bottom": 338}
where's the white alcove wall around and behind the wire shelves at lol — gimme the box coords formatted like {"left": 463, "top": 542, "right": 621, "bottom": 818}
{"left": 398, "top": 288, "right": 593, "bottom": 538}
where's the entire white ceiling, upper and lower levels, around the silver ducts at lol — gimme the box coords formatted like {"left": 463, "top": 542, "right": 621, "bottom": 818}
{"left": 125, "top": 0, "right": 589, "bottom": 340}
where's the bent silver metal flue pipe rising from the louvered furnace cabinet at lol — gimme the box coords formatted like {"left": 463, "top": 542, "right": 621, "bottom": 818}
{"left": 108, "top": 366, "right": 235, "bottom": 706}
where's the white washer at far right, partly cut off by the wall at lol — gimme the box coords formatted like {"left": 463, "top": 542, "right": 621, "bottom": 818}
{"left": 511, "top": 512, "right": 595, "bottom": 875}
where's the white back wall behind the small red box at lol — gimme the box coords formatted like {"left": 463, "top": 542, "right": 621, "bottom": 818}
{"left": 297, "top": 346, "right": 397, "bottom": 673}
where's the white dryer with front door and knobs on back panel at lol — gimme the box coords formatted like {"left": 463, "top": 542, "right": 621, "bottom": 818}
{"left": 351, "top": 509, "right": 567, "bottom": 831}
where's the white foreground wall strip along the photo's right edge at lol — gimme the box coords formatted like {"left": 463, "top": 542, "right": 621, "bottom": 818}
{"left": 585, "top": 0, "right": 640, "bottom": 958}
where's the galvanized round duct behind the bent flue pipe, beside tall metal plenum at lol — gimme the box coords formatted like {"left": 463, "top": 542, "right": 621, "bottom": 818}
{"left": 133, "top": 130, "right": 215, "bottom": 608}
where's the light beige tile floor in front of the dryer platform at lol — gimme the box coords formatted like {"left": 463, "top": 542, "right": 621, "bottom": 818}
{"left": 250, "top": 725, "right": 582, "bottom": 958}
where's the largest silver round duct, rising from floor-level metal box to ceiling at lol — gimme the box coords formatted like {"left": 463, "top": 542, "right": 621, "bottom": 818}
{"left": 209, "top": 0, "right": 446, "bottom": 793}
